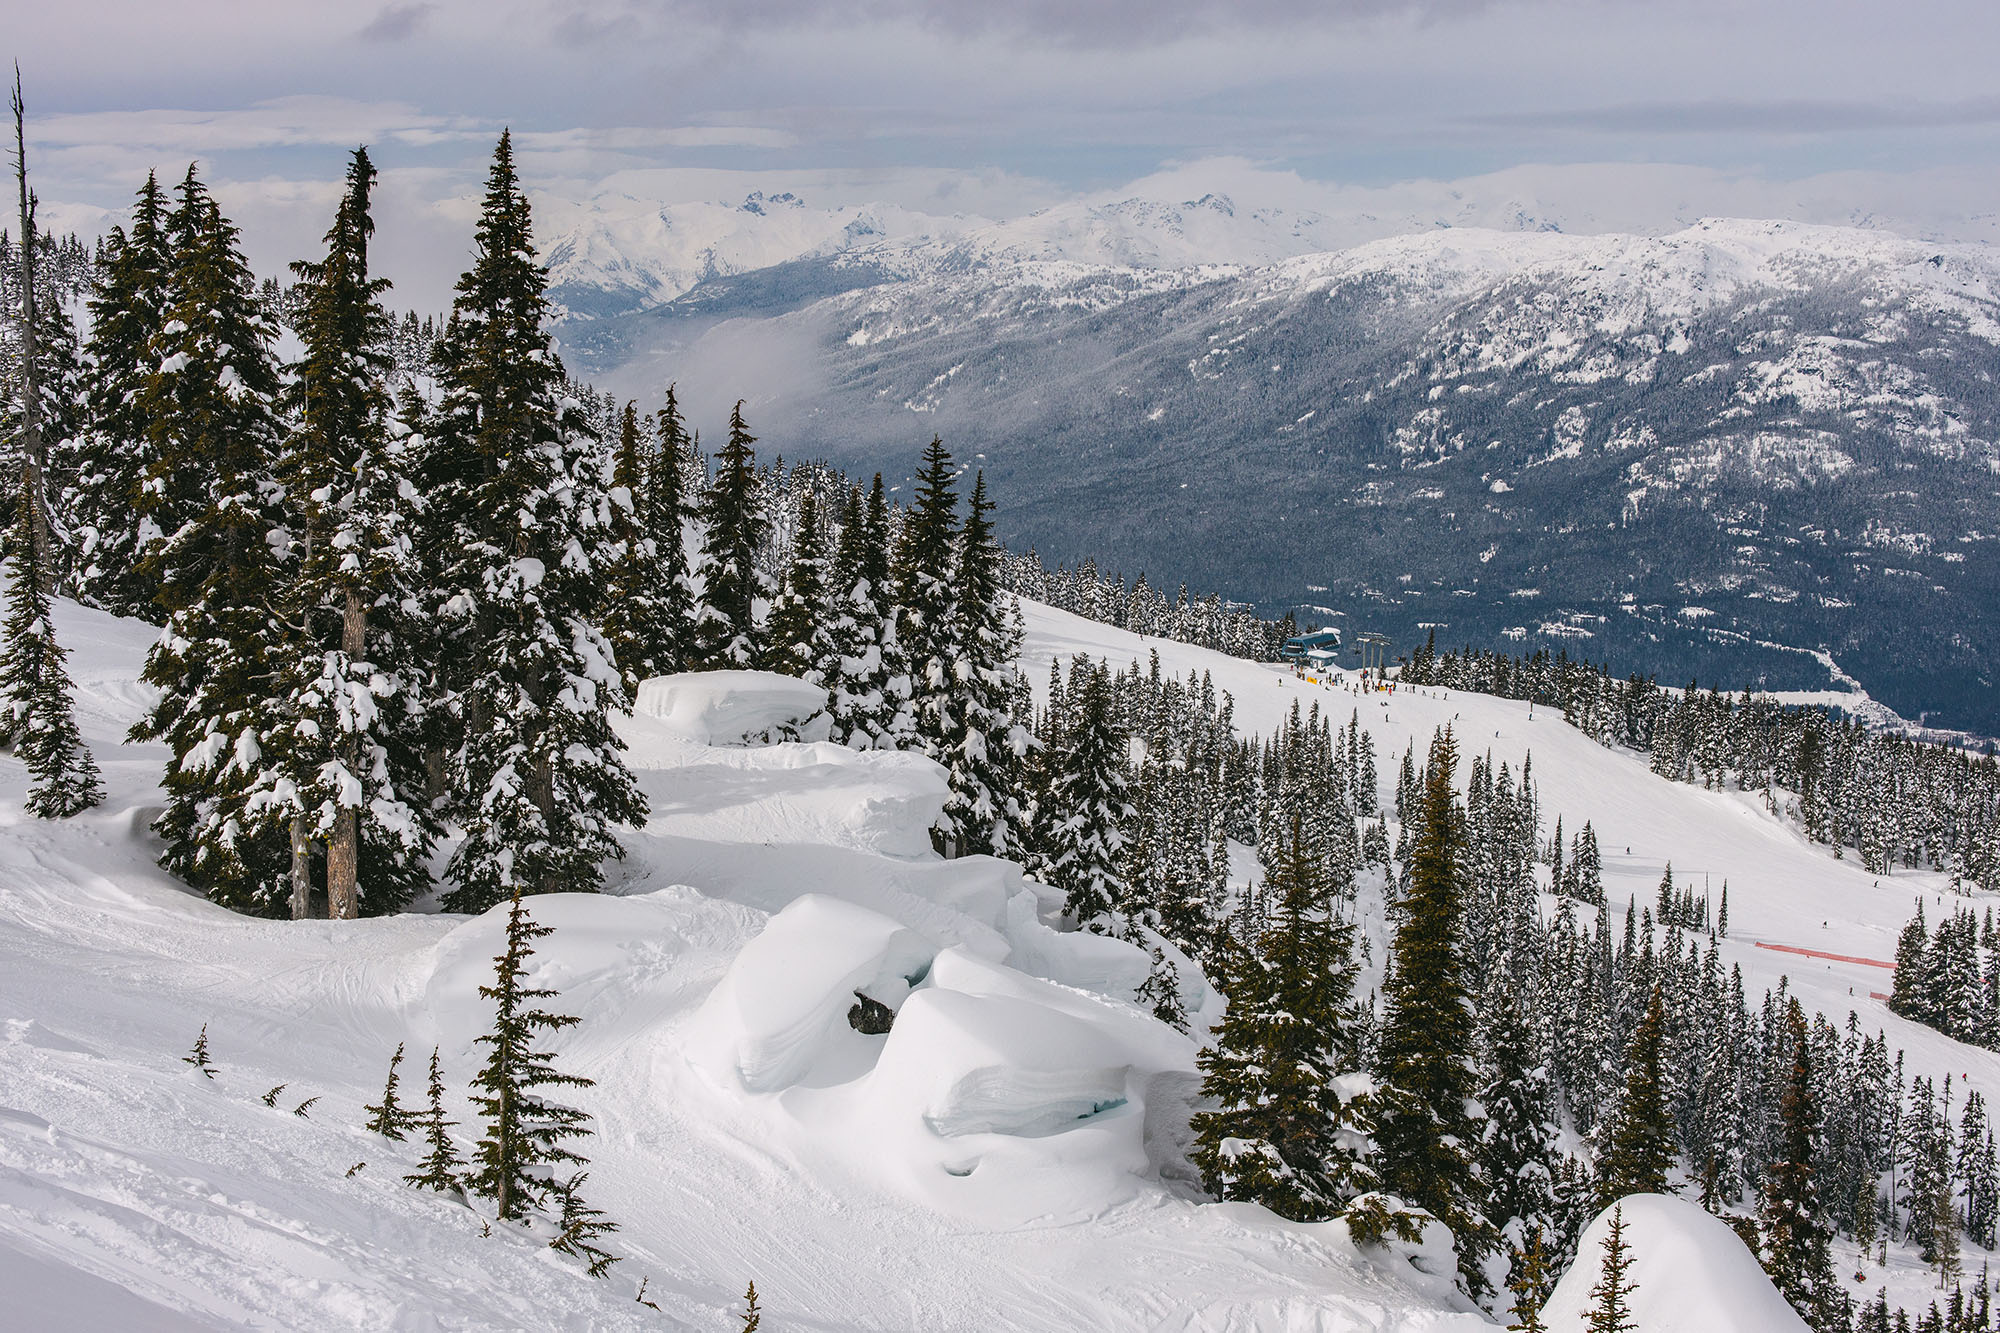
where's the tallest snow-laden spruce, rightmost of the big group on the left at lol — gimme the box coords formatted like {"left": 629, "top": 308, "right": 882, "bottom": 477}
{"left": 428, "top": 134, "right": 646, "bottom": 911}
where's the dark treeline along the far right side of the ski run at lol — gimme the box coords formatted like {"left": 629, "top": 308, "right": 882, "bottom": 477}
{"left": 1402, "top": 636, "right": 2000, "bottom": 889}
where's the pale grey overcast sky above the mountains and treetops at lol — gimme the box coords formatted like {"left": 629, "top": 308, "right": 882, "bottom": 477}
{"left": 8, "top": 0, "right": 2000, "bottom": 298}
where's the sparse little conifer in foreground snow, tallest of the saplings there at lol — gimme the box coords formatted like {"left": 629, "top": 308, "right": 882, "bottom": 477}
{"left": 470, "top": 893, "right": 592, "bottom": 1221}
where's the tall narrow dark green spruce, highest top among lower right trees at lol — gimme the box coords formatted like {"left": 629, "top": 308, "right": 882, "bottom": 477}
{"left": 1376, "top": 729, "right": 1494, "bottom": 1295}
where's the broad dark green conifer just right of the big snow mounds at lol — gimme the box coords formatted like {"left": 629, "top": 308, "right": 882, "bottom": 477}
{"left": 1192, "top": 819, "right": 1376, "bottom": 1221}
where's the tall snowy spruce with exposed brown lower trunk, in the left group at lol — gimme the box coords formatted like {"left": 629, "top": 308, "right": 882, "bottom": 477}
{"left": 252, "top": 148, "right": 438, "bottom": 921}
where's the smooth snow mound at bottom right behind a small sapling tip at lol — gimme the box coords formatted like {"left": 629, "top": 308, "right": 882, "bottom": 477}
{"left": 1542, "top": 1195, "right": 1808, "bottom": 1333}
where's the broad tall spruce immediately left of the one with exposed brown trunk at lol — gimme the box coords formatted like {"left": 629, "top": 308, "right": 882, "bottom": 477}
{"left": 134, "top": 166, "right": 290, "bottom": 917}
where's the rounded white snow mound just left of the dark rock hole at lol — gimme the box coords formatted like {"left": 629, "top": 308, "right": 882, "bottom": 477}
{"left": 692, "top": 895, "right": 936, "bottom": 1093}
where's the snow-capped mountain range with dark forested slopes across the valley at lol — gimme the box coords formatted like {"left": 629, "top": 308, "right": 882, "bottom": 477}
{"left": 550, "top": 202, "right": 2000, "bottom": 735}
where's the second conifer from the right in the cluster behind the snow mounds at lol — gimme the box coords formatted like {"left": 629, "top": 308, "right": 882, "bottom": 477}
{"left": 890, "top": 436, "right": 962, "bottom": 763}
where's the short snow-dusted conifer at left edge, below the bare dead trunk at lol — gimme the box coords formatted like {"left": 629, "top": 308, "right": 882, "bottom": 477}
{"left": 0, "top": 464, "right": 104, "bottom": 819}
